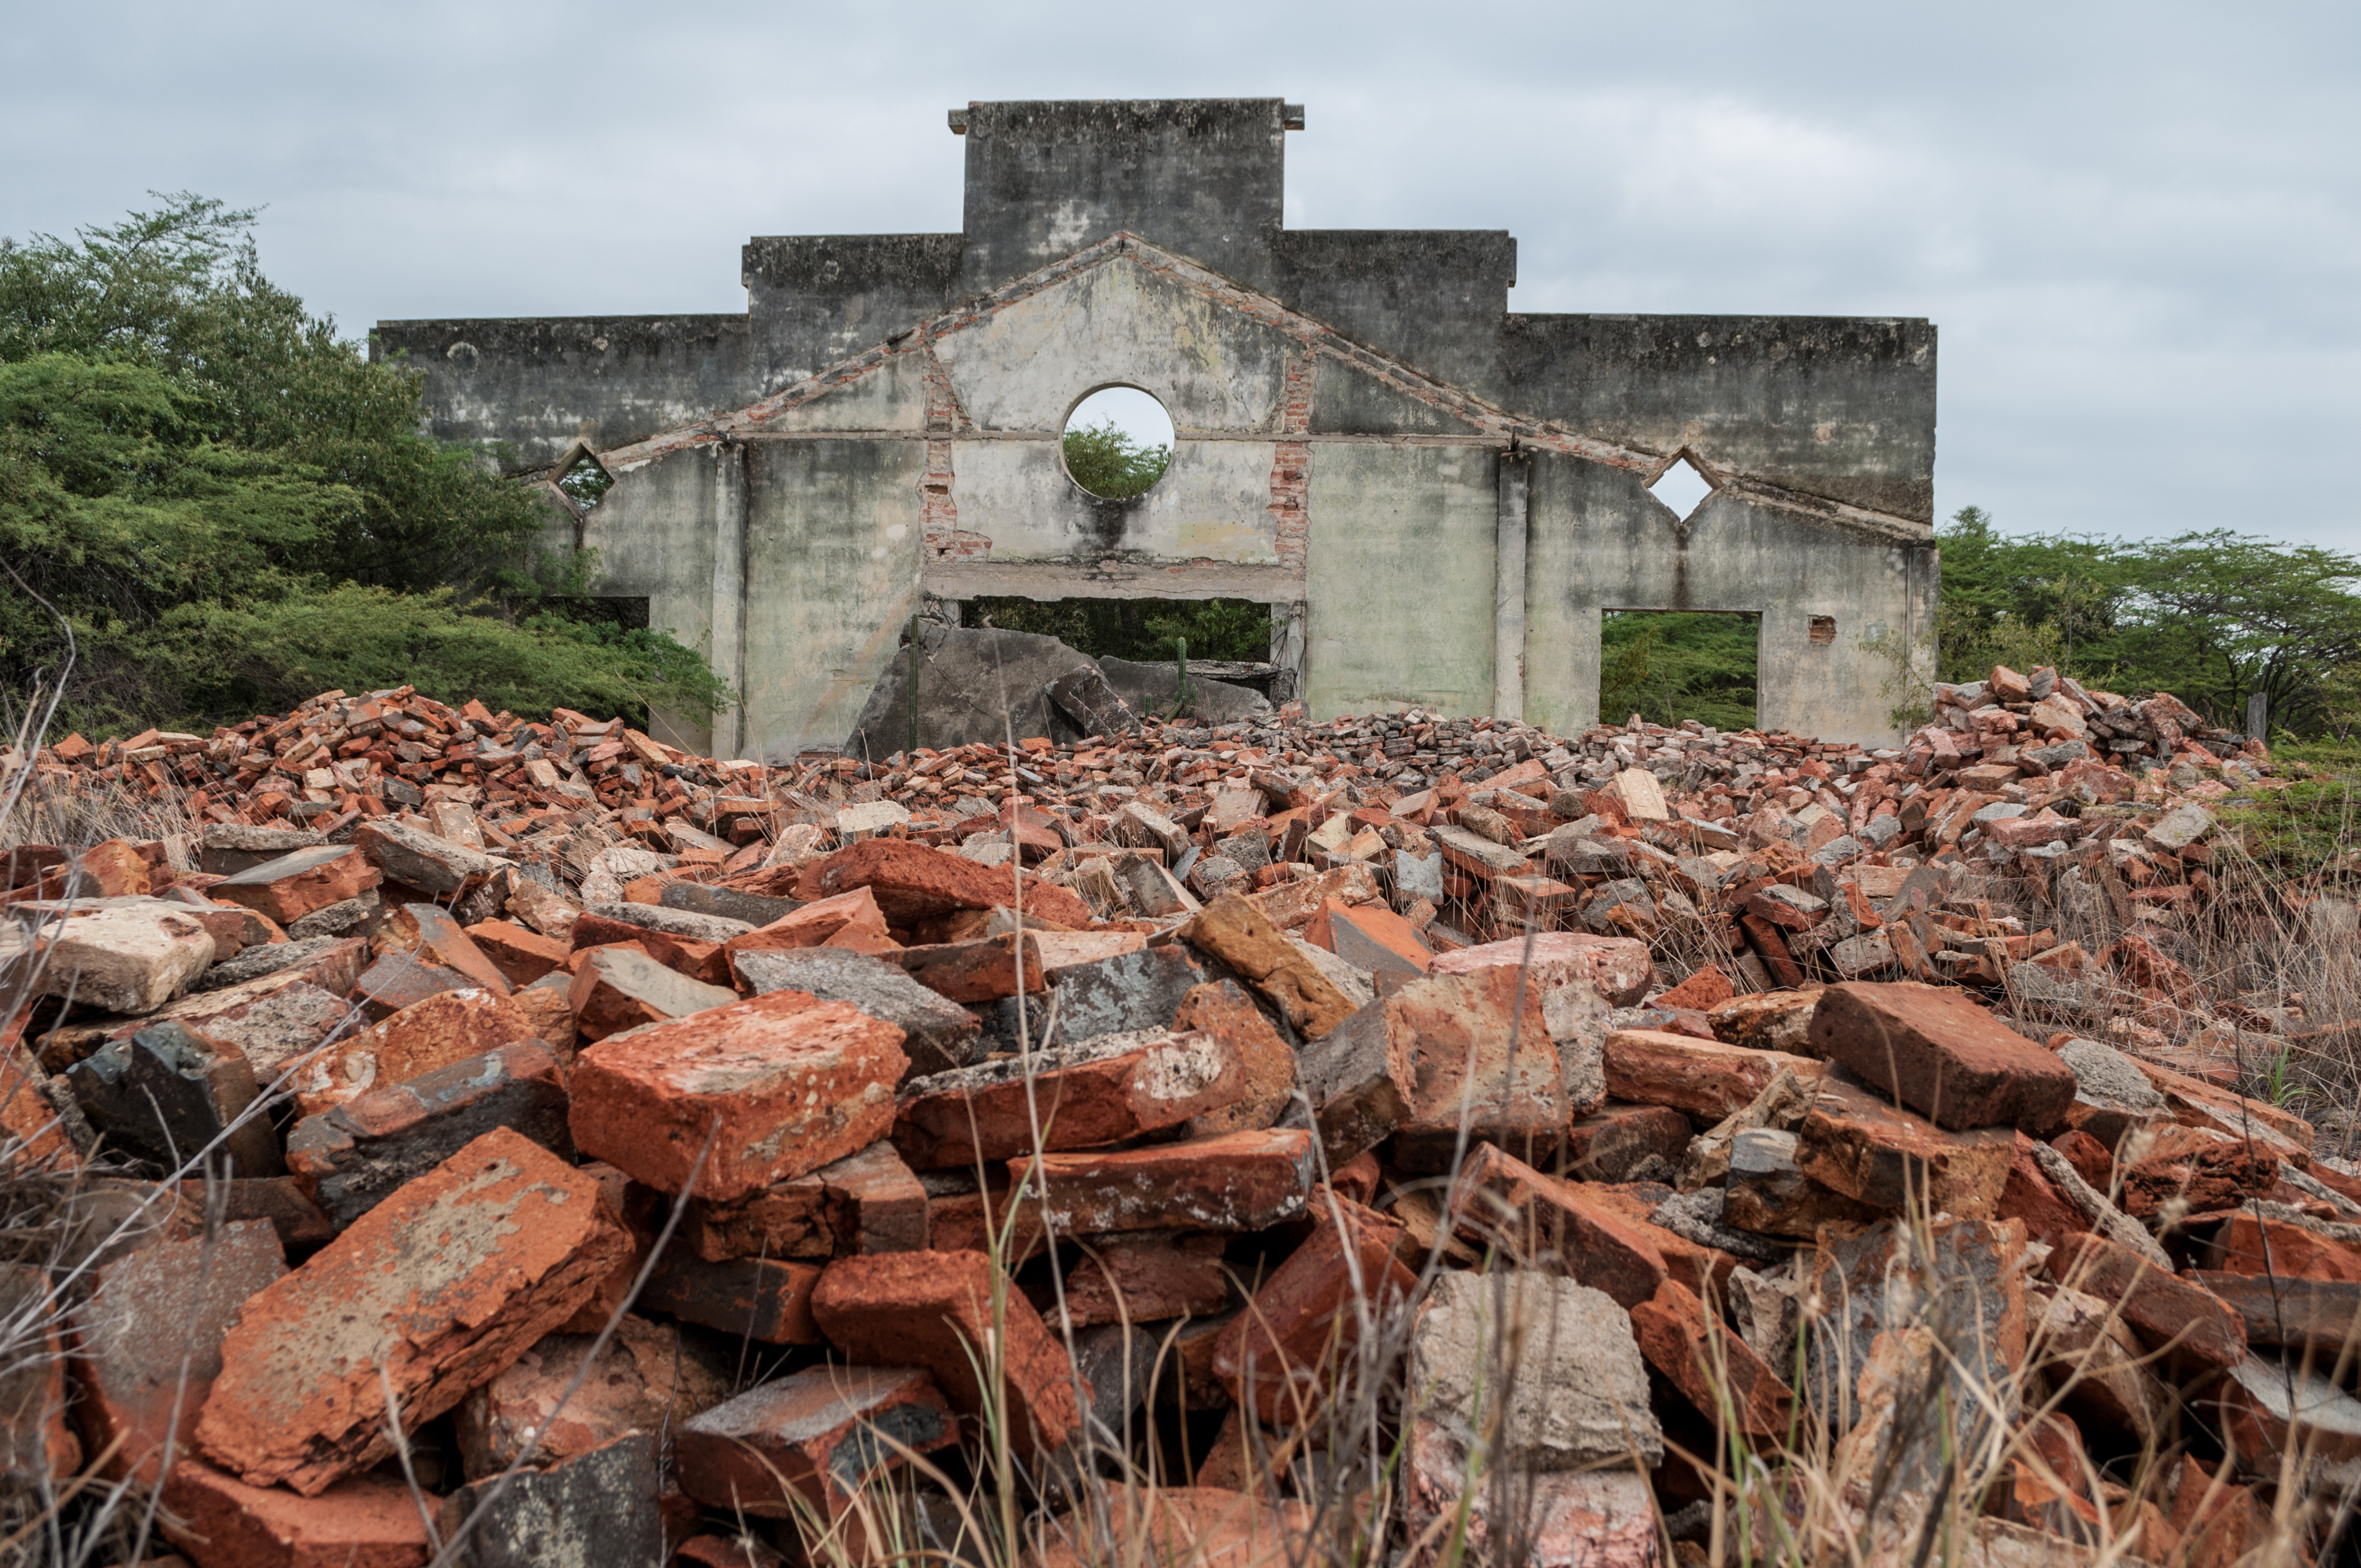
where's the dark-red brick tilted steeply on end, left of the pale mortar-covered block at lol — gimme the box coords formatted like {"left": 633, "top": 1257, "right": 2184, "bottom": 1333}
{"left": 1214, "top": 1200, "right": 1417, "bottom": 1426}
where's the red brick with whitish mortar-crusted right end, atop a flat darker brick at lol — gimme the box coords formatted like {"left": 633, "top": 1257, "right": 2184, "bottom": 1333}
{"left": 892, "top": 1030, "right": 1247, "bottom": 1169}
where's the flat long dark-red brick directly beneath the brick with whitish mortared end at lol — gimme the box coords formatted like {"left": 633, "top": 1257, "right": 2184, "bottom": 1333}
{"left": 1008, "top": 1129, "right": 1315, "bottom": 1235}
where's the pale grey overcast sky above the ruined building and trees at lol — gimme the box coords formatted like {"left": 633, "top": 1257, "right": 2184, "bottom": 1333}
{"left": 0, "top": 0, "right": 2361, "bottom": 550}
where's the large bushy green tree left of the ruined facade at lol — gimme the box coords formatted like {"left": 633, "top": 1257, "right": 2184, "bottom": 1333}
{"left": 0, "top": 196, "right": 727, "bottom": 730}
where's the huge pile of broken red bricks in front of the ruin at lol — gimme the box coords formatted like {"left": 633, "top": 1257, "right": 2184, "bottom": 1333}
{"left": 0, "top": 671, "right": 2361, "bottom": 1568}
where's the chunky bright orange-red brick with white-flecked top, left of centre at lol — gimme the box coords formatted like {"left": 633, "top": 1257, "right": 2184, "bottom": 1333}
{"left": 571, "top": 992, "right": 907, "bottom": 1202}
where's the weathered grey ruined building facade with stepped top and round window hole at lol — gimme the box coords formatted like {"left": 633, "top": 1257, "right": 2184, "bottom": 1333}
{"left": 373, "top": 99, "right": 1936, "bottom": 758}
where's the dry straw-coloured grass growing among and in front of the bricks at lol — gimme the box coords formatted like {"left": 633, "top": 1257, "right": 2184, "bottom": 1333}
{"left": 0, "top": 699, "right": 2361, "bottom": 1568}
